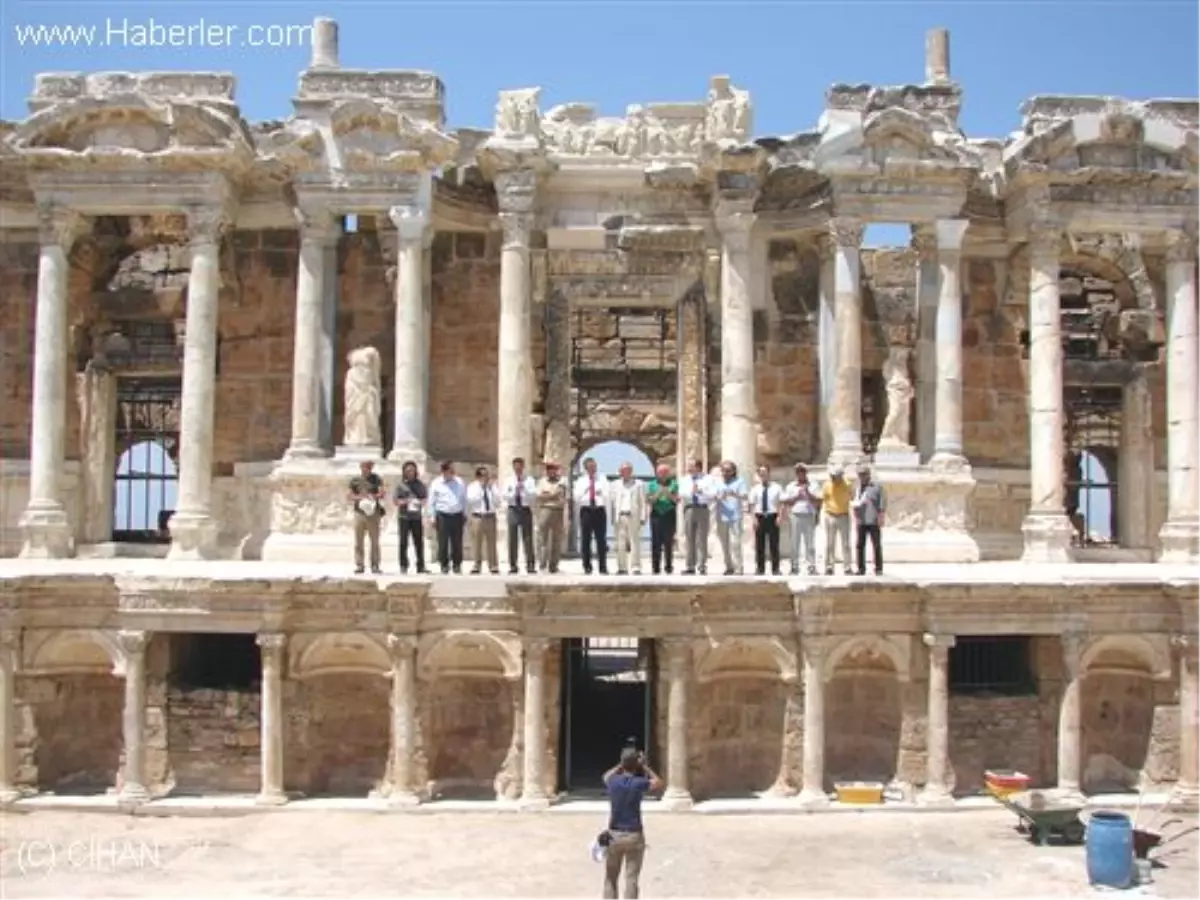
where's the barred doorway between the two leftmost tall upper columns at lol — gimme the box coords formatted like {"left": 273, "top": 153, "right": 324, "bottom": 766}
{"left": 113, "top": 378, "right": 181, "bottom": 544}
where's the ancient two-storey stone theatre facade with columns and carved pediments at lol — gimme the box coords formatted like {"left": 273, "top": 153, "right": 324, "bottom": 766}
{"left": 0, "top": 19, "right": 1200, "bottom": 808}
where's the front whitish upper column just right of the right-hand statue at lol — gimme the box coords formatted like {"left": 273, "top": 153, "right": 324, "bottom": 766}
{"left": 930, "top": 218, "right": 968, "bottom": 469}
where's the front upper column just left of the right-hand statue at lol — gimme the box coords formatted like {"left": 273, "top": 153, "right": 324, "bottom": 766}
{"left": 829, "top": 218, "right": 863, "bottom": 466}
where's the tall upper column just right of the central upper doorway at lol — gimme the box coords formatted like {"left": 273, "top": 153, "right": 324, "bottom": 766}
{"left": 716, "top": 209, "right": 758, "bottom": 472}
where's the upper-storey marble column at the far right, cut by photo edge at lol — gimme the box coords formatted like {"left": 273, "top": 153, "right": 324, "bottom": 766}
{"left": 1159, "top": 232, "right": 1200, "bottom": 565}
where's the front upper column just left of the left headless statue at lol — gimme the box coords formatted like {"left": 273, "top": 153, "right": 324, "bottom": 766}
{"left": 284, "top": 212, "right": 337, "bottom": 460}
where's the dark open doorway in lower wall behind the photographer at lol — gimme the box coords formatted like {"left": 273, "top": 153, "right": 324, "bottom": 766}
{"left": 559, "top": 637, "right": 656, "bottom": 794}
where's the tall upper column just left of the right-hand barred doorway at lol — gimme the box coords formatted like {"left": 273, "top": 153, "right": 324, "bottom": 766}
{"left": 1021, "top": 227, "right": 1073, "bottom": 563}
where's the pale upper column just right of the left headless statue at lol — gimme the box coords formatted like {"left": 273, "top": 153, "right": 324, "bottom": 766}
{"left": 388, "top": 205, "right": 430, "bottom": 466}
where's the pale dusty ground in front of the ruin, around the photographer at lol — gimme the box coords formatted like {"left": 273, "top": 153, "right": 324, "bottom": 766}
{"left": 0, "top": 810, "right": 1200, "bottom": 900}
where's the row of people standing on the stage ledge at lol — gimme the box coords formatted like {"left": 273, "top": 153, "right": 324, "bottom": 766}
{"left": 348, "top": 458, "right": 887, "bottom": 575}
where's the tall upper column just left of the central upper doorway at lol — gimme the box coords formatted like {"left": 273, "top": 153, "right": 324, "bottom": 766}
{"left": 496, "top": 170, "right": 535, "bottom": 475}
